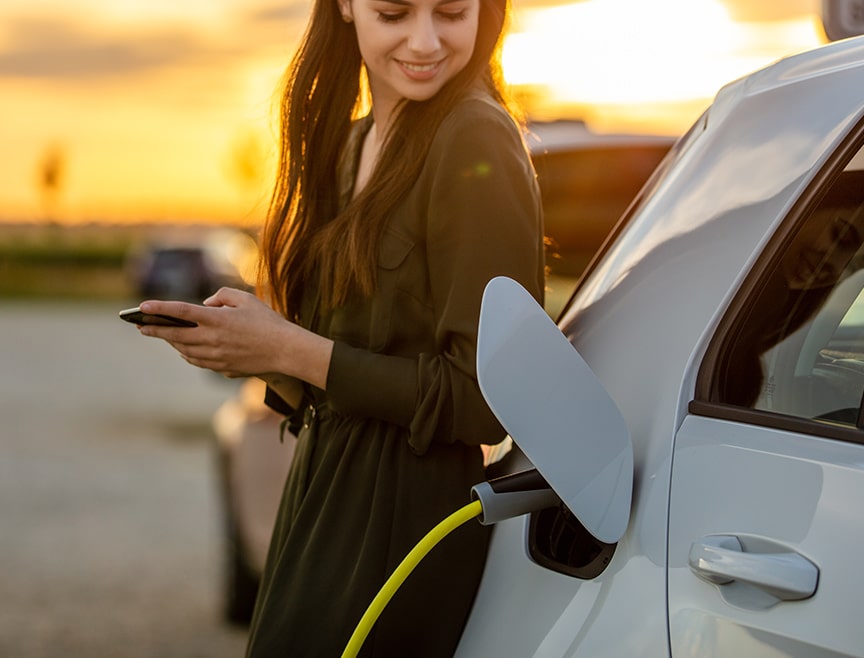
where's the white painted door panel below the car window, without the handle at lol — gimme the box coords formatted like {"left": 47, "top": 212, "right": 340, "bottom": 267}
{"left": 669, "top": 416, "right": 864, "bottom": 656}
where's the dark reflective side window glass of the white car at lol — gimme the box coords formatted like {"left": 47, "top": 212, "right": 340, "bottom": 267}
{"left": 712, "top": 147, "right": 864, "bottom": 426}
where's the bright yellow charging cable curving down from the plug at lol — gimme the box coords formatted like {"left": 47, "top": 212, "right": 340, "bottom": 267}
{"left": 342, "top": 500, "right": 483, "bottom": 658}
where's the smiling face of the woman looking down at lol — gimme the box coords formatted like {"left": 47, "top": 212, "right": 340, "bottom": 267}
{"left": 339, "top": 0, "right": 480, "bottom": 120}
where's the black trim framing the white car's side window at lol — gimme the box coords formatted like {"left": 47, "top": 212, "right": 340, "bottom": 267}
{"left": 688, "top": 116, "right": 864, "bottom": 444}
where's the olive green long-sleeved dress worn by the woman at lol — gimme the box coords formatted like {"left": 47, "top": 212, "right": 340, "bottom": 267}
{"left": 247, "top": 96, "right": 543, "bottom": 658}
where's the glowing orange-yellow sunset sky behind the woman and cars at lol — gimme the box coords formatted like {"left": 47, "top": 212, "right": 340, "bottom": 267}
{"left": 0, "top": 0, "right": 825, "bottom": 225}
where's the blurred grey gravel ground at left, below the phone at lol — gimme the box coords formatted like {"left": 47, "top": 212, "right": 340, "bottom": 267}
{"left": 0, "top": 302, "right": 246, "bottom": 658}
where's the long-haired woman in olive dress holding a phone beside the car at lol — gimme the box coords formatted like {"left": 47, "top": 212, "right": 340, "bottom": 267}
{"left": 141, "top": 0, "right": 543, "bottom": 657}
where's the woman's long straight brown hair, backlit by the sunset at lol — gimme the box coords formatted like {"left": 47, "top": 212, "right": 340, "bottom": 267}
{"left": 259, "top": 0, "right": 509, "bottom": 320}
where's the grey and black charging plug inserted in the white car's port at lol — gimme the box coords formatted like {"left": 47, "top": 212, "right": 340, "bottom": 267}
{"left": 471, "top": 468, "right": 560, "bottom": 525}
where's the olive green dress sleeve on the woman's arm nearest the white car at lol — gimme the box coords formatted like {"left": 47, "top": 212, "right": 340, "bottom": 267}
{"left": 327, "top": 100, "right": 543, "bottom": 454}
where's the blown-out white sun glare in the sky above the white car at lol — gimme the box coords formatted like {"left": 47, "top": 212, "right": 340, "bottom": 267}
{"left": 503, "top": 0, "right": 818, "bottom": 113}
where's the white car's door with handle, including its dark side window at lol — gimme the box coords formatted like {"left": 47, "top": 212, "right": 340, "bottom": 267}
{"left": 668, "top": 134, "right": 864, "bottom": 658}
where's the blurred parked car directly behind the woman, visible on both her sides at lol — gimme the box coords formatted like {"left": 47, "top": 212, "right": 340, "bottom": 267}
{"left": 213, "top": 121, "right": 675, "bottom": 624}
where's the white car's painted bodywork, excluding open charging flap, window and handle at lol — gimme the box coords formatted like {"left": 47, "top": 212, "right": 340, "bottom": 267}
{"left": 457, "top": 38, "right": 864, "bottom": 658}
